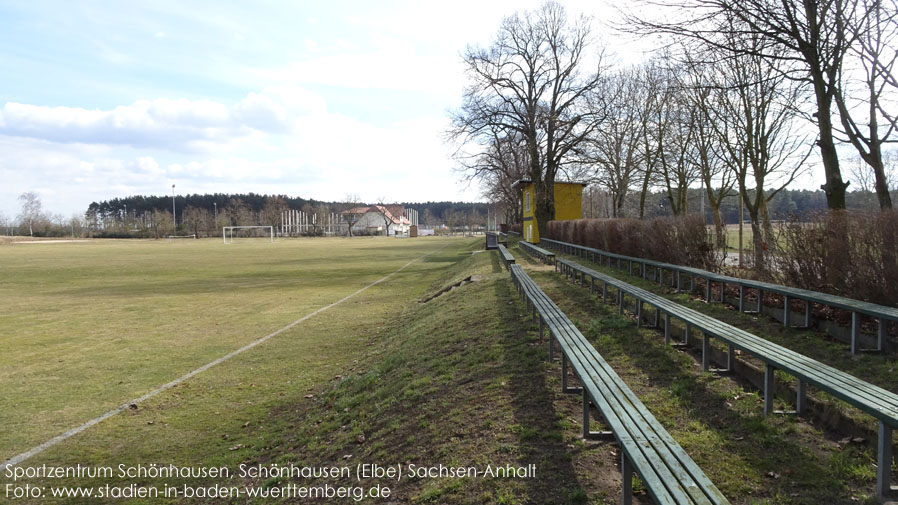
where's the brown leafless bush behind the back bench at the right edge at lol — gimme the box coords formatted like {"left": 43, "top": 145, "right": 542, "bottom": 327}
{"left": 772, "top": 211, "right": 898, "bottom": 306}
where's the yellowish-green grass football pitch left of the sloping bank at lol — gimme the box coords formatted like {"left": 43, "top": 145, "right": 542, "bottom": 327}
{"left": 0, "top": 237, "right": 479, "bottom": 472}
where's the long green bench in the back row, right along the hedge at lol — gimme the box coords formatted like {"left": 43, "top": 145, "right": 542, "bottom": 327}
{"left": 540, "top": 239, "right": 898, "bottom": 354}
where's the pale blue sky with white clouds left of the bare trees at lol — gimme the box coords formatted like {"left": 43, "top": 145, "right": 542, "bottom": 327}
{"left": 0, "top": 0, "right": 656, "bottom": 217}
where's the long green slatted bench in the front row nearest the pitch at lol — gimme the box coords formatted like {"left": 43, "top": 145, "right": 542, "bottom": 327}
{"left": 510, "top": 265, "right": 729, "bottom": 505}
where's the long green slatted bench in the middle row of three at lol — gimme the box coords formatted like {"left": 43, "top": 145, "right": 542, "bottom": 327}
{"left": 555, "top": 259, "right": 898, "bottom": 498}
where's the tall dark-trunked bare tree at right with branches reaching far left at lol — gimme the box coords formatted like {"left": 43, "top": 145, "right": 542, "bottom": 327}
{"left": 628, "top": 0, "right": 862, "bottom": 209}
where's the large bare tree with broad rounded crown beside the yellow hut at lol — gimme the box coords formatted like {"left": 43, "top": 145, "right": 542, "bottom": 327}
{"left": 450, "top": 1, "right": 602, "bottom": 235}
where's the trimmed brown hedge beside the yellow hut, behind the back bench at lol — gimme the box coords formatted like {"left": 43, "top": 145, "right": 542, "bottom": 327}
{"left": 546, "top": 216, "right": 721, "bottom": 271}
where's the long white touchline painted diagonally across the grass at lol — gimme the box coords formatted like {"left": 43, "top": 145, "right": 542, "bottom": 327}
{"left": 0, "top": 240, "right": 449, "bottom": 471}
